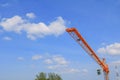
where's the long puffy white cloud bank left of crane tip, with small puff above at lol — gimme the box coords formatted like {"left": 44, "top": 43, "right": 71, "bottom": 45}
{"left": 0, "top": 13, "right": 66, "bottom": 40}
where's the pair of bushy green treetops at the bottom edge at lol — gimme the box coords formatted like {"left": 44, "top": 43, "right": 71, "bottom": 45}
{"left": 35, "top": 72, "right": 62, "bottom": 80}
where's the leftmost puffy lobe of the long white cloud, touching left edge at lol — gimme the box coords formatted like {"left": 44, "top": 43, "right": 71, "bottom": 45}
{"left": 0, "top": 16, "right": 25, "bottom": 33}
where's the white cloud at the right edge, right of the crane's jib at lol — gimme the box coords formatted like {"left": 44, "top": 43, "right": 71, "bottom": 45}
{"left": 97, "top": 43, "right": 120, "bottom": 55}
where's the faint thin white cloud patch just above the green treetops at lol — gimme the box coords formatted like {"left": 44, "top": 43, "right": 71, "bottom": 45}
{"left": 44, "top": 55, "right": 80, "bottom": 73}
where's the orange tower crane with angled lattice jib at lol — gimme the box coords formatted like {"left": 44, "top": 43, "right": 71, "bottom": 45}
{"left": 66, "top": 28, "right": 109, "bottom": 80}
